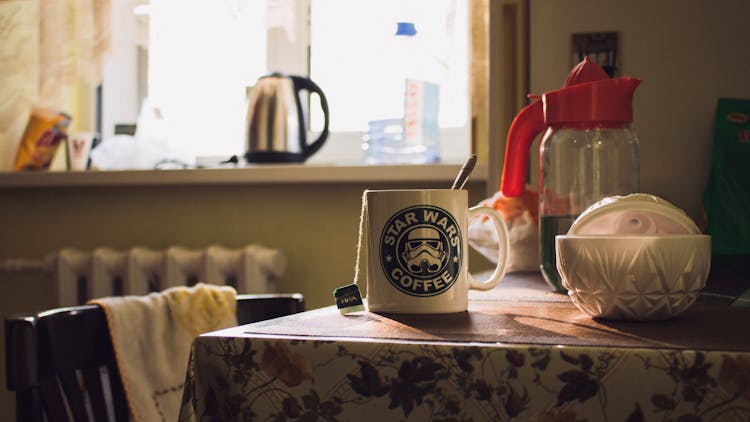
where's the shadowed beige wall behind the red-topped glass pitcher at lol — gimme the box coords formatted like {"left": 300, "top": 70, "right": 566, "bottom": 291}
{"left": 530, "top": 0, "right": 750, "bottom": 223}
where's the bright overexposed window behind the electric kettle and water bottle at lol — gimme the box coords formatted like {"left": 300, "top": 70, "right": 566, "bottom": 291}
{"left": 102, "top": 0, "right": 469, "bottom": 168}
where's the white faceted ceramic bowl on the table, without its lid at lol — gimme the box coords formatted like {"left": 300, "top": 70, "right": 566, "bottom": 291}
{"left": 555, "top": 234, "right": 711, "bottom": 321}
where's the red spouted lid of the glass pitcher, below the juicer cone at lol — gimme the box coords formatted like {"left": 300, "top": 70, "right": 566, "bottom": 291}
{"left": 542, "top": 77, "right": 641, "bottom": 125}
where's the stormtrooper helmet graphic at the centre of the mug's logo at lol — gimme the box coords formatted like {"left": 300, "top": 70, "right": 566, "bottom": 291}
{"left": 401, "top": 226, "right": 446, "bottom": 276}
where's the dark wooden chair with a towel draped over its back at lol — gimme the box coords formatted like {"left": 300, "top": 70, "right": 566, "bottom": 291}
{"left": 5, "top": 294, "right": 305, "bottom": 422}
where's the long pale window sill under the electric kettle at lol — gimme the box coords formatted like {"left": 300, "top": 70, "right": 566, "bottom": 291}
{"left": 0, "top": 164, "right": 488, "bottom": 188}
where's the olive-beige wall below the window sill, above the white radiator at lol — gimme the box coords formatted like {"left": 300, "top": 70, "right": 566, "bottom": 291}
{"left": 0, "top": 180, "right": 488, "bottom": 419}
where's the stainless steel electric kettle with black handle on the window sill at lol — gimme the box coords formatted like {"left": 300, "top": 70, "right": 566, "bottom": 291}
{"left": 245, "top": 73, "right": 328, "bottom": 163}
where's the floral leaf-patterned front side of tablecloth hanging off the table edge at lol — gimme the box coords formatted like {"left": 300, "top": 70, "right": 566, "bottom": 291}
{"left": 180, "top": 337, "right": 750, "bottom": 422}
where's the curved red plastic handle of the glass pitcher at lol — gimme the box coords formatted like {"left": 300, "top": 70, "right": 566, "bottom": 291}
{"left": 500, "top": 98, "right": 546, "bottom": 197}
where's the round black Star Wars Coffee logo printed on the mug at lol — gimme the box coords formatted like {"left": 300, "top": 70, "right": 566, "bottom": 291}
{"left": 380, "top": 205, "right": 462, "bottom": 296}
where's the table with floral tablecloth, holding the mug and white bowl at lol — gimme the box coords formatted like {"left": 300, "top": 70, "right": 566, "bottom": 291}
{"left": 180, "top": 273, "right": 750, "bottom": 421}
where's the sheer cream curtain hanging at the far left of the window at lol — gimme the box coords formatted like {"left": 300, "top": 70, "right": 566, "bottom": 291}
{"left": 0, "top": 0, "right": 110, "bottom": 171}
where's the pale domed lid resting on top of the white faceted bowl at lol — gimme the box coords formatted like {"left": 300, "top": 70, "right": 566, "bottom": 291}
{"left": 568, "top": 193, "right": 701, "bottom": 235}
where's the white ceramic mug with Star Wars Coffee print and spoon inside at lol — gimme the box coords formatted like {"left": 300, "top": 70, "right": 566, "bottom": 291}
{"left": 365, "top": 189, "right": 509, "bottom": 314}
